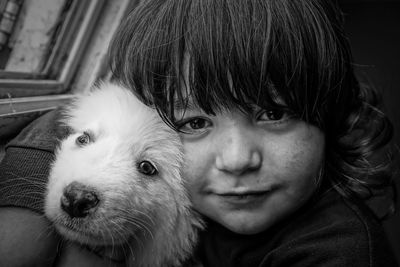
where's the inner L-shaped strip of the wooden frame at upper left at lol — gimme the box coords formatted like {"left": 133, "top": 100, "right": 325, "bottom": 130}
{"left": 0, "top": 0, "right": 105, "bottom": 98}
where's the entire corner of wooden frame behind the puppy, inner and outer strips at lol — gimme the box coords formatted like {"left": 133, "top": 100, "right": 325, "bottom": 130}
{"left": 0, "top": 0, "right": 135, "bottom": 141}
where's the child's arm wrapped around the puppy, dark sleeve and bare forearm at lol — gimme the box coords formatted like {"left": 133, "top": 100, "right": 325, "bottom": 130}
{"left": 0, "top": 111, "right": 126, "bottom": 267}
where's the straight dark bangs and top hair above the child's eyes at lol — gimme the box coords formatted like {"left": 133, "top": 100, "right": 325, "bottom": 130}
{"left": 110, "top": 0, "right": 351, "bottom": 126}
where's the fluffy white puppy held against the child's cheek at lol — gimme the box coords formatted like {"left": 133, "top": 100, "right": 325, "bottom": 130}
{"left": 45, "top": 83, "right": 201, "bottom": 267}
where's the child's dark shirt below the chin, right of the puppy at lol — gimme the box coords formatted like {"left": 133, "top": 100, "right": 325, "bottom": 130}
{"left": 198, "top": 189, "right": 397, "bottom": 267}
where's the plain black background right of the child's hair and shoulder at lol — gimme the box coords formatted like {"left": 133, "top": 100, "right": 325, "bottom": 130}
{"left": 340, "top": 0, "right": 400, "bottom": 263}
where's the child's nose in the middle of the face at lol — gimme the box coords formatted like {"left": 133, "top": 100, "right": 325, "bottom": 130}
{"left": 215, "top": 128, "right": 262, "bottom": 175}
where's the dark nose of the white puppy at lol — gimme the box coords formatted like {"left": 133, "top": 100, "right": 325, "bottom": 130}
{"left": 61, "top": 182, "right": 99, "bottom": 218}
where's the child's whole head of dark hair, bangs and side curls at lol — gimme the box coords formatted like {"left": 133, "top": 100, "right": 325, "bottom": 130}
{"left": 110, "top": 0, "right": 393, "bottom": 218}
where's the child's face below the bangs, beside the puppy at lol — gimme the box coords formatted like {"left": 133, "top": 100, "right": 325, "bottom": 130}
{"left": 176, "top": 102, "right": 325, "bottom": 234}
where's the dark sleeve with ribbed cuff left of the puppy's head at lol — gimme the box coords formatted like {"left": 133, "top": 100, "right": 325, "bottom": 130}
{"left": 0, "top": 110, "right": 67, "bottom": 213}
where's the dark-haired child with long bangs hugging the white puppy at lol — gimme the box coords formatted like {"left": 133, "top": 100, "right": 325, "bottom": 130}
{"left": 2, "top": 0, "right": 396, "bottom": 267}
